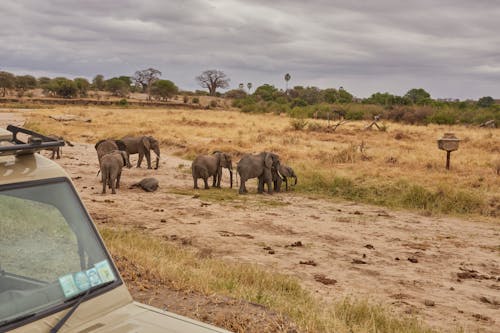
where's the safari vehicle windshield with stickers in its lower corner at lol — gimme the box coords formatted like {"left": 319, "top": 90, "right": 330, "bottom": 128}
{"left": 0, "top": 179, "right": 118, "bottom": 326}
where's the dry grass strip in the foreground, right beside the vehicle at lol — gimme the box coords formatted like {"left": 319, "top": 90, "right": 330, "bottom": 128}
{"left": 101, "top": 229, "right": 438, "bottom": 333}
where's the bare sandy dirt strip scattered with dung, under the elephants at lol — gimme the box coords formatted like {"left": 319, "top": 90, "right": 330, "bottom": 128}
{"left": 0, "top": 113, "right": 500, "bottom": 332}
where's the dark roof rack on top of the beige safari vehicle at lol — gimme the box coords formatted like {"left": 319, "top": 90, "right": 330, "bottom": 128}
{"left": 0, "top": 125, "right": 64, "bottom": 156}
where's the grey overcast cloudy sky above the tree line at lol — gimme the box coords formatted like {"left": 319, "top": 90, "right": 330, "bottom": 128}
{"left": 0, "top": 0, "right": 500, "bottom": 99}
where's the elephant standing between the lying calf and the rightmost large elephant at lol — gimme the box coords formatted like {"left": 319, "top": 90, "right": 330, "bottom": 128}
{"left": 191, "top": 151, "right": 233, "bottom": 189}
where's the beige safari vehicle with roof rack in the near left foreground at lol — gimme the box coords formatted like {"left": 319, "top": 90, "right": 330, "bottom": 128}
{"left": 0, "top": 125, "right": 227, "bottom": 333}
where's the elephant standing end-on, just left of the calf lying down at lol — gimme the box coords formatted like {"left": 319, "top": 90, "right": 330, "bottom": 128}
{"left": 100, "top": 150, "right": 127, "bottom": 194}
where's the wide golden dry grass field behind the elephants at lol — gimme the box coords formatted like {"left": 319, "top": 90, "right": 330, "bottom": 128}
{"left": 19, "top": 106, "right": 500, "bottom": 216}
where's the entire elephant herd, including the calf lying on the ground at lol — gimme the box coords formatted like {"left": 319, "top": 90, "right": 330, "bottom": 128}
{"left": 94, "top": 136, "right": 297, "bottom": 194}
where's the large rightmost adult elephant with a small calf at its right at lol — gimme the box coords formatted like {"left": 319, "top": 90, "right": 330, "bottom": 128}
{"left": 236, "top": 152, "right": 280, "bottom": 194}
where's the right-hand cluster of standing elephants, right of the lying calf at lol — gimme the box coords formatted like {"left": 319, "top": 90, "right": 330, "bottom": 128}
{"left": 191, "top": 151, "right": 297, "bottom": 194}
